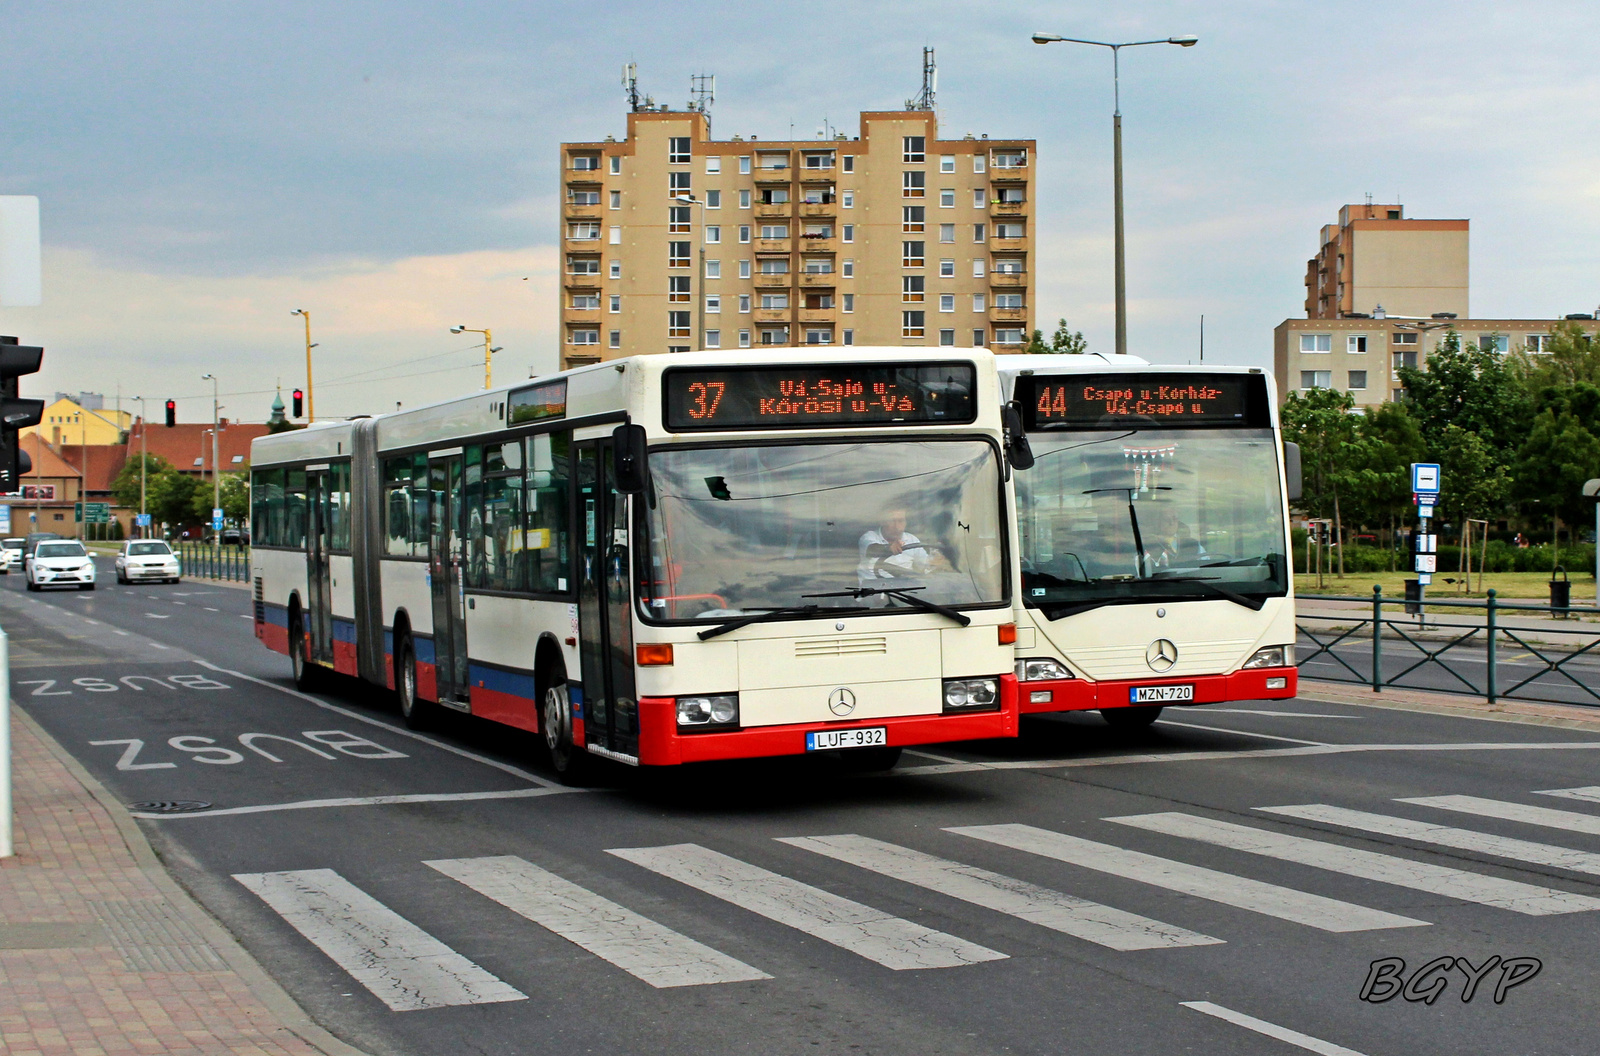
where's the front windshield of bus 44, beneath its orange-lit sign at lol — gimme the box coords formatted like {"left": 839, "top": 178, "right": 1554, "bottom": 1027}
{"left": 1016, "top": 429, "right": 1288, "bottom": 618}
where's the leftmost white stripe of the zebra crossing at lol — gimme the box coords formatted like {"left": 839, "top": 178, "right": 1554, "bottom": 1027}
{"left": 234, "top": 869, "right": 528, "bottom": 1011}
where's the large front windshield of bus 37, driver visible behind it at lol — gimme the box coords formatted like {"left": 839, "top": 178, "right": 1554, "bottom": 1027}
{"left": 640, "top": 438, "right": 1008, "bottom": 619}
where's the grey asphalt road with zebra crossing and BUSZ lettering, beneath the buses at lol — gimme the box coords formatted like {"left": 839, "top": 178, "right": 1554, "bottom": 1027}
{"left": 0, "top": 562, "right": 1600, "bottom": 1056}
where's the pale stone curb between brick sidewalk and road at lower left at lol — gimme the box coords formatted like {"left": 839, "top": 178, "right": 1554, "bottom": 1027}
{"left": 11, "top": 701, "right": 370, "bottom": 1056}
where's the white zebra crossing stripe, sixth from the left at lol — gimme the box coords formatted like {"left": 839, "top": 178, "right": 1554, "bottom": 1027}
{"left": 1104, "top": 811, "right": 1600, "bottom": 917}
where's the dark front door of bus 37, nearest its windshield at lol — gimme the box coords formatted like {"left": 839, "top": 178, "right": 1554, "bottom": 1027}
{"left": 573, "top": 438, "right": 638, "bottom": 758}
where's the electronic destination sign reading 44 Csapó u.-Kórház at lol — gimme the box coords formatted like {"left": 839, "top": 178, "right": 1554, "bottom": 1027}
{"left": 1016, "top": 373, "right": 1270, "bottom": 429}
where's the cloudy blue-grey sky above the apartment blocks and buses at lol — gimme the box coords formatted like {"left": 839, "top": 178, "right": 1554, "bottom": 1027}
{"left": 0, "top": 0, "right": 1600, "bottom": 421}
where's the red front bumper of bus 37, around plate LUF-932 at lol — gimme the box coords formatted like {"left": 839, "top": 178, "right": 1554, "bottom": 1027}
{"left": 638, "top": 675, "right": 1018, "bottom": 766}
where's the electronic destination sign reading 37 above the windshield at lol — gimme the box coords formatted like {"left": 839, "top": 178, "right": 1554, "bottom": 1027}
{"left": 662, "top": 363, "right": 978, "bottom": 432}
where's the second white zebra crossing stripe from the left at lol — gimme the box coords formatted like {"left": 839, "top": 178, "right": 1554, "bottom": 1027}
{"left": 422, "top": 854, "right": 771, "bottom": 989}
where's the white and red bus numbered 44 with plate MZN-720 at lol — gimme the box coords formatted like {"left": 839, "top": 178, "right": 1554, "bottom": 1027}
{"left": 997, "top": 355, "right": 1299, "bottom": 726}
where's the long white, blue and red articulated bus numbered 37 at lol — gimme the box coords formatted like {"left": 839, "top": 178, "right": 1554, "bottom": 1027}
{"left": 251, "top": 349, "right": 1018, "bottom": 773}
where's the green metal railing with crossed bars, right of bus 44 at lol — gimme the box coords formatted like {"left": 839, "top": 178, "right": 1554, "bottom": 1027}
{"left": 1294, "top": 587, "right": 1600, "bottom": 707}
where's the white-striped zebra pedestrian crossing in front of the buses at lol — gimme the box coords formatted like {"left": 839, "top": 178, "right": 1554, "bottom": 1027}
{"left": 235, "top": 786, "right": 1600, "bottom": 1011}
